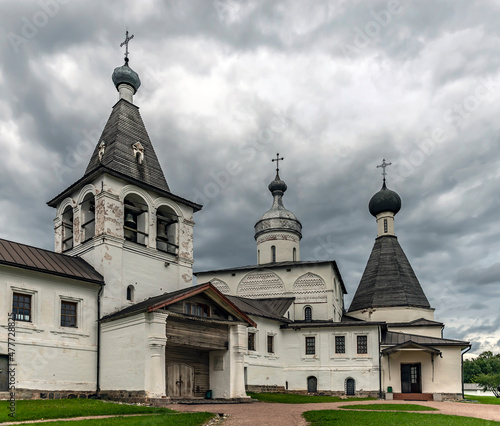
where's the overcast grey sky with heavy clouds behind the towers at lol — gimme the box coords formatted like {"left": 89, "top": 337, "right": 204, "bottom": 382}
{"left": 0, "top": 0, "right": 500, "bottom": 354}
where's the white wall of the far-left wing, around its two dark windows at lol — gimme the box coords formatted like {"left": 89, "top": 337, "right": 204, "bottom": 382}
{"left": 0, "top": 266, "right": 99, "bottom": 391}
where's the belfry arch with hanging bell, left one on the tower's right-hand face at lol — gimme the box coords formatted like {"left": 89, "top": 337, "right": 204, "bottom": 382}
{"left": 123, "top": 194, "right": 148, "bottom": 245}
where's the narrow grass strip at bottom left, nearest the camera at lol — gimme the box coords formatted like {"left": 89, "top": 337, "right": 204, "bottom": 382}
{"left": 26, "top": 413, "right": 214, "bottom": 426}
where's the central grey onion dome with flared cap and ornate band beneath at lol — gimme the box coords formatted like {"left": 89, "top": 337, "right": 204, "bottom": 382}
{"left": 255, "top": 173, "right": 302, "bottom": 239}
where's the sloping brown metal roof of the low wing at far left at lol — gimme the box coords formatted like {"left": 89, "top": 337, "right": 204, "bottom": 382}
{"left": 0, "top": 238, "right": 104, "bottom": 284}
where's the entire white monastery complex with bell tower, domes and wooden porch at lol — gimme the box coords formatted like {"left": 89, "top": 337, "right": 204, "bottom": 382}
{"left": 0, "top": 46, "right": 470, "bottom": 400}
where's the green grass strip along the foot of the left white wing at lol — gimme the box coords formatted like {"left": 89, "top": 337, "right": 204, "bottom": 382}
{"left": 0, "top": 399, "right": 211, "bottom": 424}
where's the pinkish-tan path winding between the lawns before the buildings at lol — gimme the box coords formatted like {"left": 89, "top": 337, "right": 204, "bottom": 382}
{"left": 169, "top": 401, "right": 500, "bottom": 426}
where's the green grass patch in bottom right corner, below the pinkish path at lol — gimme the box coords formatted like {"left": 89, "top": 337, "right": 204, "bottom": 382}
{"left": 304, "top": 410, "right": 498, "bottom": 426}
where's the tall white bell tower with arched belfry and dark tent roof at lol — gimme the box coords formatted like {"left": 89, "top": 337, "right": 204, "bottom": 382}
{"left": 48, "top": 32, "right": 201, "bottom": 314}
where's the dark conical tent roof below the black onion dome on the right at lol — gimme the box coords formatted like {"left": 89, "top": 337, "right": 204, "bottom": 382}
{"left": 349, "top": 235, "right": 431, "bottom": 312}
